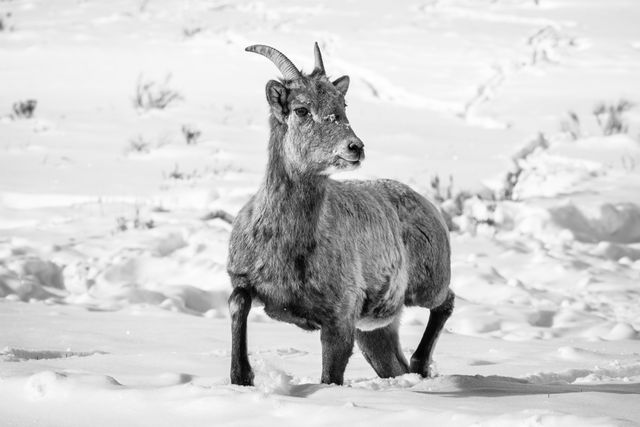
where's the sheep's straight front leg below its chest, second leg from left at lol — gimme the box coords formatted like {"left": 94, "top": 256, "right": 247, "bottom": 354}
{"left": 320, "top": 325, "right": 355, "bottom": 385}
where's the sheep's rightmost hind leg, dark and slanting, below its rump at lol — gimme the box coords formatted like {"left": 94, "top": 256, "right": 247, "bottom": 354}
{"left": 410, "top": 290, "right": 455, "bottom": 378}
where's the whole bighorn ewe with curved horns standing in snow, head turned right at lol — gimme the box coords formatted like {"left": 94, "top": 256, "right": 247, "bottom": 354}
{"left": 227, "top": 43, "right": 454, "bottom": 385}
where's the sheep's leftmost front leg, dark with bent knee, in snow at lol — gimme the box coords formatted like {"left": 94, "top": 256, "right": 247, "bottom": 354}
{"left": 229, "top": 287, "right": 253, "bottom": 385}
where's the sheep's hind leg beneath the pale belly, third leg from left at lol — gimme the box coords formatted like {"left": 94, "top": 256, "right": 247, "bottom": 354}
{"left": 356, "top": 318, "right": 409, "bottom": 378}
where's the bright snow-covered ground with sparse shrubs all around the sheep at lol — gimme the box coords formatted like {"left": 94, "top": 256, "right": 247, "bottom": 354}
{"left": 0, "top": 0, "right": 640, "bottom": 426}
